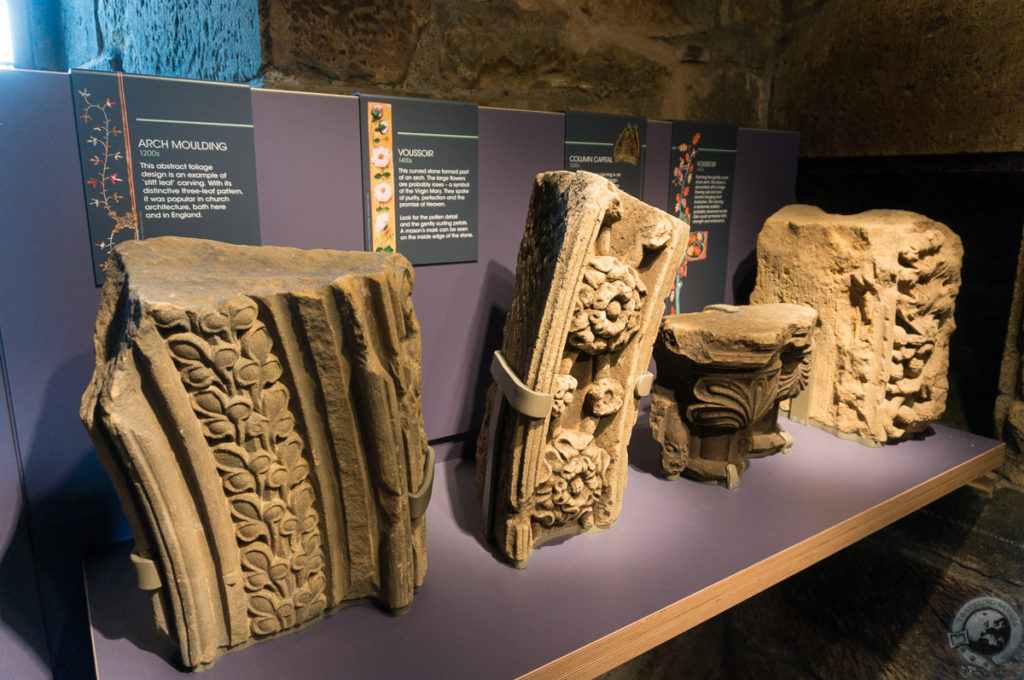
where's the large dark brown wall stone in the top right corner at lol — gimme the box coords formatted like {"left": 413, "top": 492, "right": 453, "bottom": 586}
{"left": 768, "top": 0, "right": 1024, "bottom": 156}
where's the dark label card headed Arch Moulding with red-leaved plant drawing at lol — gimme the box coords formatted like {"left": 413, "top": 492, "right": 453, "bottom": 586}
{"left": 71, "top": 71, "right": 260, "bottom": 285}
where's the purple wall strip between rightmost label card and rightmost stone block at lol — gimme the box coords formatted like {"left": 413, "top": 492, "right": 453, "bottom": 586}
{"left": 725, "top": 128, "right": 800, "bottom": 304}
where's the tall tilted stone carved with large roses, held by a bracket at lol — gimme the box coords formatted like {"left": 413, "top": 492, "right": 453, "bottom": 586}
{"left": 477, "top": 172, "right": 688, "bottom": 566}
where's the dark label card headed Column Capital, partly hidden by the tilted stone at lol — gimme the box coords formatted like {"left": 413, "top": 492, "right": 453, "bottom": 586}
{"left": 565, "top": 111, "right": 647, "bottom": 200}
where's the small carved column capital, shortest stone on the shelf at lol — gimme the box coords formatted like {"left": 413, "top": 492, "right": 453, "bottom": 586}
{"left": 650, "top": 304, "right": 818, "bottom": 488}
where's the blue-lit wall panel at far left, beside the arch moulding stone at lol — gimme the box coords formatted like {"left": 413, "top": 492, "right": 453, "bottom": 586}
{"left": 0, "top": 71, "right": 120, "bottom": 544}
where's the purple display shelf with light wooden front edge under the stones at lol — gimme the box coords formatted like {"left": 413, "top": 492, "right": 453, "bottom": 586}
{"left": 84, "top": 421, "right": 1004, "bottom": 680}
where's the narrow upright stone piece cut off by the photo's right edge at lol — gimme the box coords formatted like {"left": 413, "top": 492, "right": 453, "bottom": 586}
{"left": 995, "top": 225, "right": 1024, "bottom": 485}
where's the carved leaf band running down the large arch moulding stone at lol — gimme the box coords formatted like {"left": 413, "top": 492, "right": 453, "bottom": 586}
{"left": 153, "top": 296, "right": 327, "bottom": 636}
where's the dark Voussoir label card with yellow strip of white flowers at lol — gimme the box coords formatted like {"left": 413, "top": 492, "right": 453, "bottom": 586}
{"left": 359, "top": 94, "right": 478, "bottom": 264}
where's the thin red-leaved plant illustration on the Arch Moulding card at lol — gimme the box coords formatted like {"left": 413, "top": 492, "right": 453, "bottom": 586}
{"left": 78, "top": 82, "right": 141, "bottom": 271}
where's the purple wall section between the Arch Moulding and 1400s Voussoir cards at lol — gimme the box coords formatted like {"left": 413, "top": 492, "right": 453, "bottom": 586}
{"left": 252, "top": 90, "right": 362, "bottom": 250}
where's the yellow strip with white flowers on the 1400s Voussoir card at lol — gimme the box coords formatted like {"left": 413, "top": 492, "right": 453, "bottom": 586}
{"left": 367, "top": 101, "right": 396, "bottom": 253}
